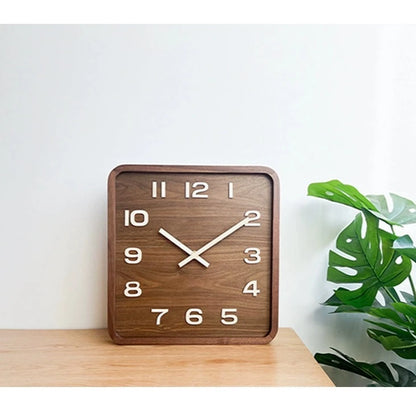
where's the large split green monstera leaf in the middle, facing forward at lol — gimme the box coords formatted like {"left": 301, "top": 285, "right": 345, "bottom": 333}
{"left": 327, "top": 213, "right": 411, "bottom": 308}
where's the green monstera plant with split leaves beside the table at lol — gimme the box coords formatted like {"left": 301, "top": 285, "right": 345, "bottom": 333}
{"left": 308, "top": 180, "right": 416, "bottom": 387}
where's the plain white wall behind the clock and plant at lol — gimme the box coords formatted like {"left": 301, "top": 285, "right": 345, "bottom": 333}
{"left": 0, "top": 25, "right": 416, "bottom": 384}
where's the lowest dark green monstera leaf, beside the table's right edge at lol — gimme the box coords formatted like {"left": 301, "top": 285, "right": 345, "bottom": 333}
{"left": 315, "top": 348, "right": 416, "bottom": 387}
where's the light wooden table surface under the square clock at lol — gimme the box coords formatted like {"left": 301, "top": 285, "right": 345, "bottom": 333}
{"left": 0, "top": 328, "right": 333, "bottom": 387}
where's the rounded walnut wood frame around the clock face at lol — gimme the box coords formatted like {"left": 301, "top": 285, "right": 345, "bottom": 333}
{"left": 108, "top": 165, "right": 279, "bottom": 345}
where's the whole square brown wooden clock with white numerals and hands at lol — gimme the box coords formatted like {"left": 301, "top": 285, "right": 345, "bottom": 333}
{"left": 108, "top": 165, "right": 279, "bottom": 344}
